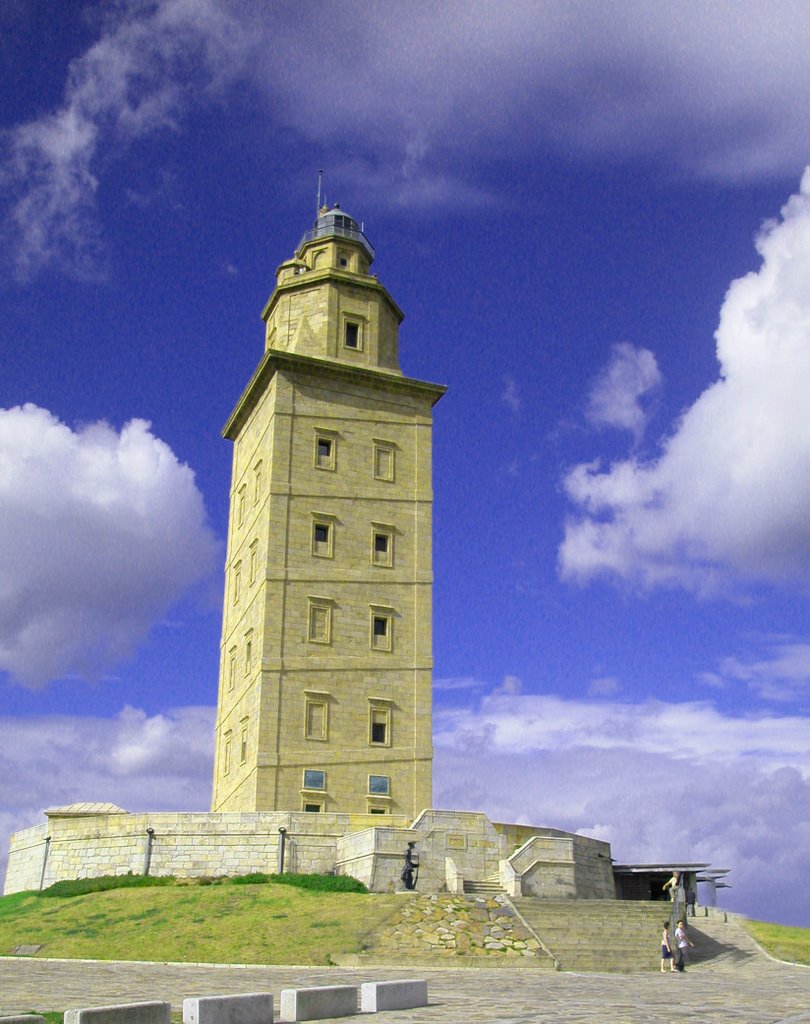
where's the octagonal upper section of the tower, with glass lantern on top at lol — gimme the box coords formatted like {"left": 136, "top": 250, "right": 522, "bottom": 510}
{"left": 262, "top": 206, "right": 403, "bottom": 373}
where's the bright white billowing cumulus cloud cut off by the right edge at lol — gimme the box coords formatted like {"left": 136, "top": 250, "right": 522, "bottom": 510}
{"left": 559, "top": 169, "right": 810, "bottom": 592}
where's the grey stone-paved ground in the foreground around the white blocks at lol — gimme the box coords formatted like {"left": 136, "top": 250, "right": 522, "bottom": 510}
{"left": 0, "top": 955, "right": 810, "bottom": 1024}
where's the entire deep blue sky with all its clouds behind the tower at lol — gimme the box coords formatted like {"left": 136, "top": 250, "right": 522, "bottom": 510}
{"left": 0, "top": 0, "right": 810, "bottom": 925}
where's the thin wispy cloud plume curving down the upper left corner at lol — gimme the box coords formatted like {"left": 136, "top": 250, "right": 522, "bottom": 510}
{"left": 0, "top": 0, "right": 247, "bottom": 279}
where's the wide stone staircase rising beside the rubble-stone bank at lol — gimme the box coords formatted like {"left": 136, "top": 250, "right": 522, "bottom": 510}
{"left": 512, "top": 896, "right": 670, "bottom": 973}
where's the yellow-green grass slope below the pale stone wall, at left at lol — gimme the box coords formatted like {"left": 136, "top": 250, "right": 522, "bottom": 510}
{"left": 0, "top": 883, "right": 398, "bottom": 966}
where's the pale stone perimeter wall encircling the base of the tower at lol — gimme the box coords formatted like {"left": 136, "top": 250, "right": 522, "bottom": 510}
{"left": 4, "top": 809, "right": 614, "bottom": 899}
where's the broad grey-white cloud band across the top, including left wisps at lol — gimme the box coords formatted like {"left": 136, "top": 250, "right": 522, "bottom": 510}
{"left": 0, "top": 0, "right": 810, "bottom": 278}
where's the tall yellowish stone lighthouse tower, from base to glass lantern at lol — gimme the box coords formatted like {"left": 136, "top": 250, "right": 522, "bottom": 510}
{"left": 212, "top": 207, "right": 444, "bottom": 818}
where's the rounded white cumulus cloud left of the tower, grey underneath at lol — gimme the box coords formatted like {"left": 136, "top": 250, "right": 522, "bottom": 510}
{"left": 0, "top": 404, "right": 218, "bottom": 686}
